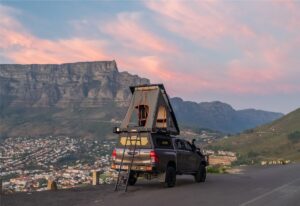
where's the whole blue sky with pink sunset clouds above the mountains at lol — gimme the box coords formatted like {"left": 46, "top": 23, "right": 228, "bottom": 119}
{"left": 0, "top": 0, "right": 300, "bottom": 113}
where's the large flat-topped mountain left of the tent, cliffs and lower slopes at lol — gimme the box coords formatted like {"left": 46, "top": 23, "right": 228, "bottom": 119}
{"left": 0, "top": 61, "right": 149, "bottom": 137}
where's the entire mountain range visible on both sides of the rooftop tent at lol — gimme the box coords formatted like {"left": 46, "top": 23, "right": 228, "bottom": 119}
{"left": 0, "top": 61, "right": 281, "bottom": 138}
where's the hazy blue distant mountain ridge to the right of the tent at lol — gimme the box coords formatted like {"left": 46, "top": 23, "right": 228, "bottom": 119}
{"left": 171, "top": 97, "right": 283, "bottom": 133}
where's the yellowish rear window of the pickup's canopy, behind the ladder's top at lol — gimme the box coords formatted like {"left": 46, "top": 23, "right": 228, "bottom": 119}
{"left": 118, "top": 134, "right": 151, "bottom": 149}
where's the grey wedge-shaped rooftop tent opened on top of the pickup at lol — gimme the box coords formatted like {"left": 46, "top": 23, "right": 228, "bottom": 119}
{"left": 121, "top": 84, "right": 180, "bottom": 135}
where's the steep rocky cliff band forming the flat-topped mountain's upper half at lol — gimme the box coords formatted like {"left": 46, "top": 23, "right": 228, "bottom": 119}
{"left": 0, "top": 61, "right": 149, "bottom": 108}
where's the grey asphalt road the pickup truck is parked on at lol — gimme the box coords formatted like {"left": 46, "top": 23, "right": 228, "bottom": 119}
{"left": 0, "top": 164, "right": 300, "bottom": 206}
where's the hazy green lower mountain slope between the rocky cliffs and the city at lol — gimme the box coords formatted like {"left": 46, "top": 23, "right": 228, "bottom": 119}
{"left": 0, "top": 104, "right": 125, "bottom": 141}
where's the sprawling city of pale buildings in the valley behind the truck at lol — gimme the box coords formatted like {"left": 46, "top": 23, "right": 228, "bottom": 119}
{"left": 0, "top": 132, "right": 236, "bottom": 193}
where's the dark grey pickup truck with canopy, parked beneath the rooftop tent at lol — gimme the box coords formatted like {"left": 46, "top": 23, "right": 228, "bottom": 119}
{"left": 111, "top": 132, "right": 208, "bottom": 187}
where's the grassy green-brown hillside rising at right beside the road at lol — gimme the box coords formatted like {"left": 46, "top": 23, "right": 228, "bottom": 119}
{"left": 213, "top": 109, "right": 300, "bottom": 162}
